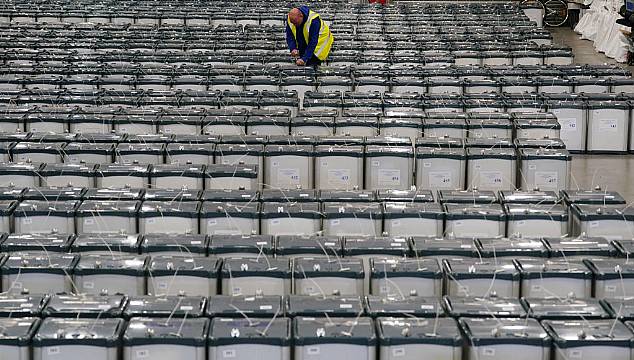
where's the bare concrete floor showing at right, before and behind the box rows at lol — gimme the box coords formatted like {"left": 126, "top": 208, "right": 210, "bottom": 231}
{"left": 550, "top": 27, "right": 634, "bottom": 202}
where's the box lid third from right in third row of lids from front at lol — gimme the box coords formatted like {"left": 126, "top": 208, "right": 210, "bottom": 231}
{"left": 442, "top": 257, "right": 520, "bottom": 281}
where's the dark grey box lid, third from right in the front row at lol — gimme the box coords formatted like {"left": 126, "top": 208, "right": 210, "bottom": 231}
{"left": 377, "top": 317, "right": 463, "bottom": 348}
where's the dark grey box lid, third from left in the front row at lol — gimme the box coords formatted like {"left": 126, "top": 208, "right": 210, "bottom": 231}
{"left": 123, "top": 317, "right": 209, "bottom": 347}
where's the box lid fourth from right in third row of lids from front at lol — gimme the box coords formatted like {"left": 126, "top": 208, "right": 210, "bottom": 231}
{"left": 370, "top": 257, "right": 442, "bottom": 280}
